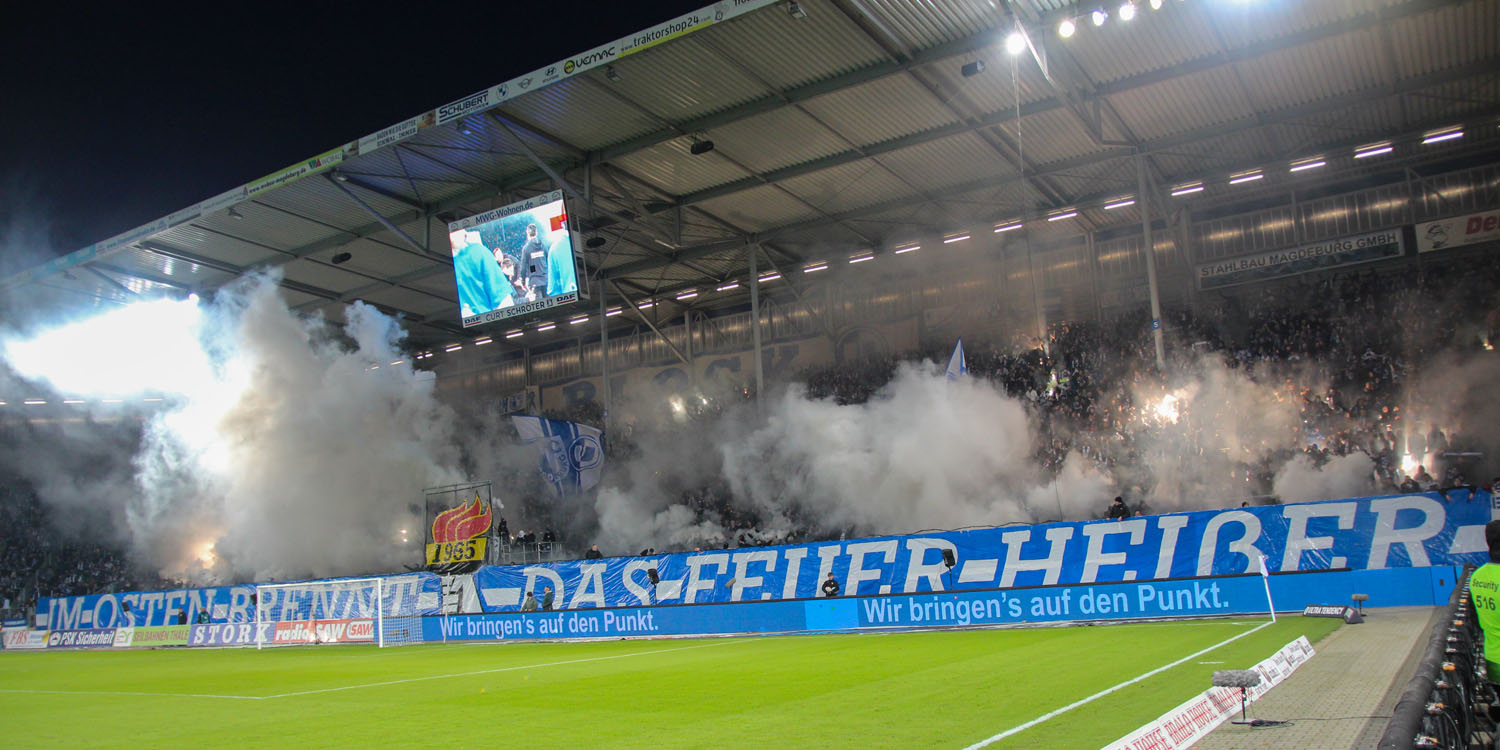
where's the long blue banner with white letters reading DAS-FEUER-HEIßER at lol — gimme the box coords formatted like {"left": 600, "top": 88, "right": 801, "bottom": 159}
{"left": 474, "top": 491, "right": 1490, "bottom": 612}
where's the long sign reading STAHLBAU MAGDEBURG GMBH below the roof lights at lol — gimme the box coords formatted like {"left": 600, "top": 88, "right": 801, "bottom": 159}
{"left": 1199, "top": 230, "right": 1406, "bottom": 290}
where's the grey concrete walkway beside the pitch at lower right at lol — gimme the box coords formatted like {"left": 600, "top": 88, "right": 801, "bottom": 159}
{"left": 1193, "top": 608, "right": 1442, "bottom": 750}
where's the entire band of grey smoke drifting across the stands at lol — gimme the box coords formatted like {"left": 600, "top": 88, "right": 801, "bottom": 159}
{"left": 0, "top": 264, "right": 1497, "bottom": 582}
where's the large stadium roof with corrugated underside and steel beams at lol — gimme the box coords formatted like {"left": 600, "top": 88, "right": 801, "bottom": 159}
{"left": 6, "top": 0, "right": 1500, "bottom": 347}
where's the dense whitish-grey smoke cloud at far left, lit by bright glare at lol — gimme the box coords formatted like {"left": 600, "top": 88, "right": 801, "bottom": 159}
{"left": 5, "top": 278, "right": 464, "bottom": 581}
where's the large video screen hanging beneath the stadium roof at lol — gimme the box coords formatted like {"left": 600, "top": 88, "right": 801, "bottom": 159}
{"left": 449, "top": 191, "right": 588, "bottom": 329}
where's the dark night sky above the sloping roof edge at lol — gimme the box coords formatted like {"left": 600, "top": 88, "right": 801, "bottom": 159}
{"left": 0, "top": 0, "right": 708, "bottom": 276}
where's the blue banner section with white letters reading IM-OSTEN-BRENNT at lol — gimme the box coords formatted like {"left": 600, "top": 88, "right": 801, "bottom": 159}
{"left": 38, "top": 573, "right": 441, "bottom": 630}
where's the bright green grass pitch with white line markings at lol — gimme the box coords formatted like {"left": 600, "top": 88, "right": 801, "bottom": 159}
{"left": 0, "top": 617, "right": 1343, "bottom": 750}
